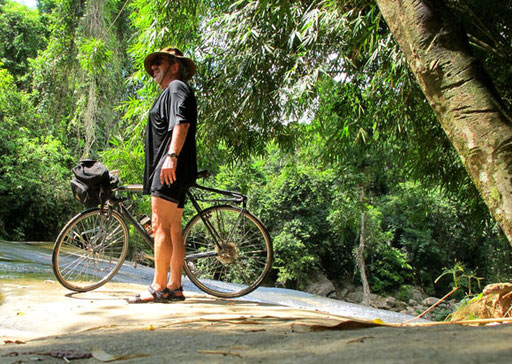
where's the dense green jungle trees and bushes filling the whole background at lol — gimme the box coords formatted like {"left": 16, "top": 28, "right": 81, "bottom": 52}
{"left": 0, "top": 0, "right": 512, "bottom": 295}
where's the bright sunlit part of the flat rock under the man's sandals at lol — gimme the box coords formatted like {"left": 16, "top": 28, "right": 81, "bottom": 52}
{"left": 0, "top": 281, "right": 373, "bottom": 341}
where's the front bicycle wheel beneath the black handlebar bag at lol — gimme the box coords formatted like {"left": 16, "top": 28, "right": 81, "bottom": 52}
{"left": 52, "top": 208, "right": 128, "bottom": 292}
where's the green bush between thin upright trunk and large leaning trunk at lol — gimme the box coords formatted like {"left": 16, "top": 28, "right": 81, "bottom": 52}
{"left": 380, "top": 184, "right": 502, "bottom": 294}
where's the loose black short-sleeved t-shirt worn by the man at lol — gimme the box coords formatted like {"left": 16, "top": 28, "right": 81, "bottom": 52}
{"left": 144, "top": 80, "right": 197, "bottom": 194}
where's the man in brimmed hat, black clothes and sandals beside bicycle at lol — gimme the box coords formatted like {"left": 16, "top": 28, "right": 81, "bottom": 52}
{"left": 128, "top": 47, "right": 197, "bottom": 303}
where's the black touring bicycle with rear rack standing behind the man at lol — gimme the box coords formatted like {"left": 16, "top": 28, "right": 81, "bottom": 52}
{"left": 52, "top": 170, "right": 273, "bottom": 298}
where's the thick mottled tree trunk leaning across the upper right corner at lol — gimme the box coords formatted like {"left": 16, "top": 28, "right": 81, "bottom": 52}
{"left": 377, "top": 0, "right": 512, "bottom": 243}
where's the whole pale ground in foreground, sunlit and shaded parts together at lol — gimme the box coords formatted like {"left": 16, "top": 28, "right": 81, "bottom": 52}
{"left": 0, "top": 281, "right": 512, "bottom": 363}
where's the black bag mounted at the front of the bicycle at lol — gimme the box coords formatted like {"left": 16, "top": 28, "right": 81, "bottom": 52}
{"left": 71, "top": 159, "right": 117, "bottom": 207}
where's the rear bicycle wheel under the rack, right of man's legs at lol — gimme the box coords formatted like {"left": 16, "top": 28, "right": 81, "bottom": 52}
{"left": 183, "top": 206, "right": 273, "bottom": 298}
